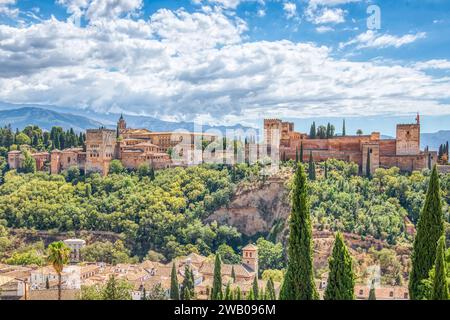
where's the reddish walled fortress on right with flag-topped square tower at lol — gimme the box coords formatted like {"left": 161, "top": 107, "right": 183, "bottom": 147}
{"left": 264, "top": 115, "right": 437, "bottom": 174}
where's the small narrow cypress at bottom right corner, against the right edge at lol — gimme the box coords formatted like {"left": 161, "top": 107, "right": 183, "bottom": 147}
{"left": 432, "top": 236, "right": 449, "bottom": 300}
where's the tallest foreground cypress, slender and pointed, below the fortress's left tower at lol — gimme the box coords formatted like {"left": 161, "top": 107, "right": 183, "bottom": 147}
{"left": 280, "top": 164, "right": 318, "bottom": 300}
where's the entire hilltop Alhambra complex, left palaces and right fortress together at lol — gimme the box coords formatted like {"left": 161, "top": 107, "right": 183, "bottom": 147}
{"left": 8, "top": 115, "right": 438, "bottom": 175}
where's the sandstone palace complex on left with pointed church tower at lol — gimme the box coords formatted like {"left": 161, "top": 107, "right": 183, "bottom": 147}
{"left": 8, "top": 116, "right": 216, "bottom": 175}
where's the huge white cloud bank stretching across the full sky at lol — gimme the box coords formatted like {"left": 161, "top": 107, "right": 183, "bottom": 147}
{"left": 0, "top": 9, "right": 450, "bottom": 122}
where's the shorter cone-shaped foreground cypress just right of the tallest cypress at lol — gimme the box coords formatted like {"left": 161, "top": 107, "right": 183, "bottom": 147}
{"left": 324, "top": 232, "right": 355, "bottom": 300}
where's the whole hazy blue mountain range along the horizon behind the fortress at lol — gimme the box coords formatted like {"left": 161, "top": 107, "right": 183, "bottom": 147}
{"left": 0, "top": 102, "right": 450, "bottom": 150}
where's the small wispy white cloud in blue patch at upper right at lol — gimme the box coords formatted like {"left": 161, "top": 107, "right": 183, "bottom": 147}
{"left": 339, "top": 30, "right": 426, "bottom": 49}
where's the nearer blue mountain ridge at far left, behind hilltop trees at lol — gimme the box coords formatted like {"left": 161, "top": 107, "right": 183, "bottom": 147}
{"left": 0, "top": 107, "right": 102, "bottom": 131}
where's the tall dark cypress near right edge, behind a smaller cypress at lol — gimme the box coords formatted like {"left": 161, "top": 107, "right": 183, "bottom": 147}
{"left": 409, "top": 166, "right": 444, "bottom": 300}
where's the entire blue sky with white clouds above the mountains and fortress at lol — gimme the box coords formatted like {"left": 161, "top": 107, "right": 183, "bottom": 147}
{"left": 0, "top": 0, "right": 450, "bottom": 129}
